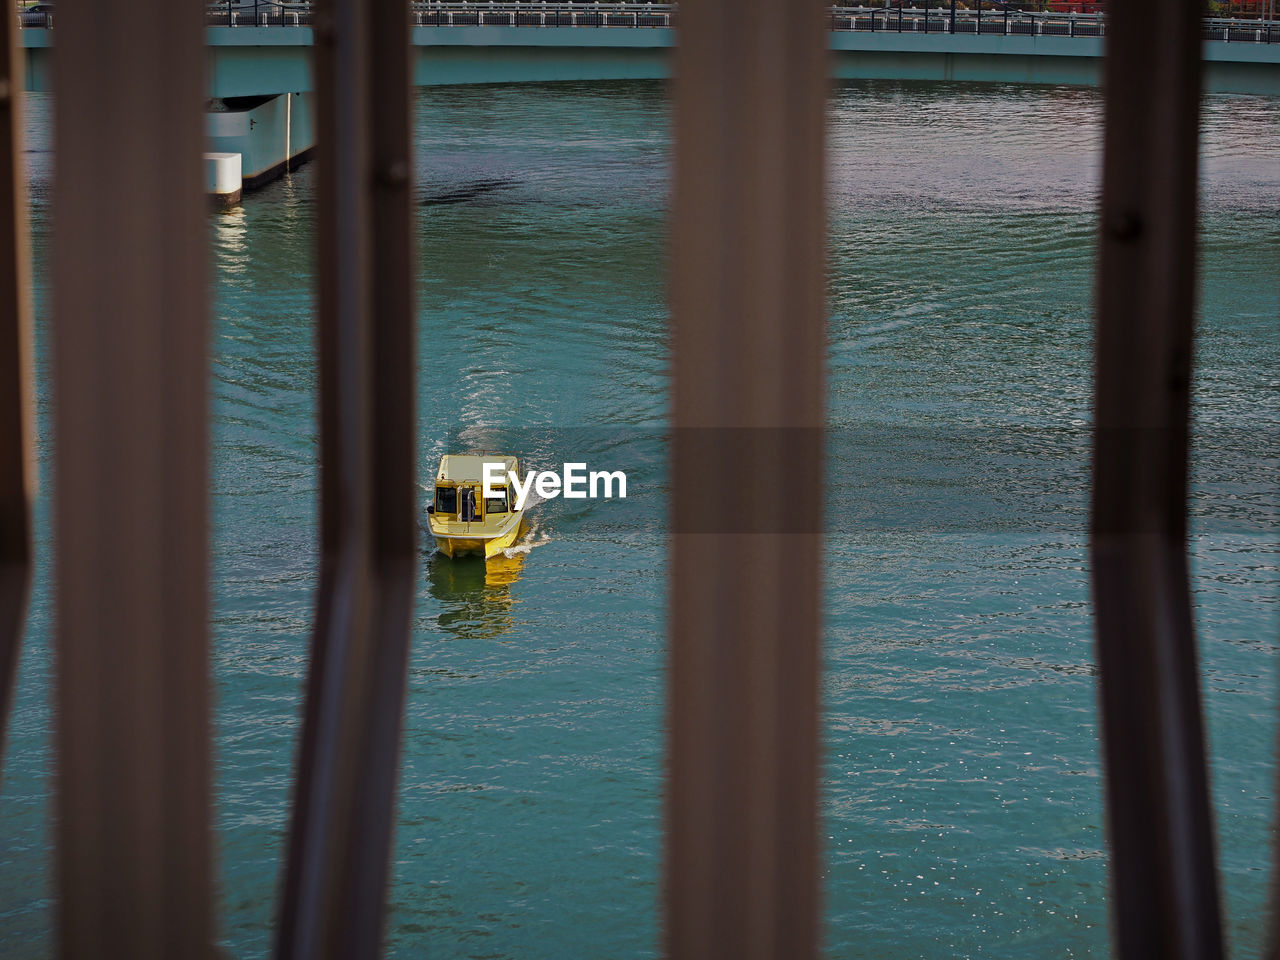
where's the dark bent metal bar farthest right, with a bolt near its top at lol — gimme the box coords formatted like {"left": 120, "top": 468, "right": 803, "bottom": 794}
{"left": 1091, "top": 0, "right": 1222, "bottom": 960}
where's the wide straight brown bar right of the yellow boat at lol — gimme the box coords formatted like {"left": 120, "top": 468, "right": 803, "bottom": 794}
{"left": 664, "top": 0, "right": 827, "bottom": 960}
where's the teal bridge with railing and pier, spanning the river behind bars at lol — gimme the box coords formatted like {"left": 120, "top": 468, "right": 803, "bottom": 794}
{"left": 12, "top": 0, "right": 1280, "bottom": 199}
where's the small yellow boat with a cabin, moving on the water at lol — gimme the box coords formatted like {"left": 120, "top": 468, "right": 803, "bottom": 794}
{"left": 426, "top": 453, "right": 525, "bottom": 559}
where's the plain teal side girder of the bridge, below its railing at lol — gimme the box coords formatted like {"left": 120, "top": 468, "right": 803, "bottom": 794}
{"left": 23, "top": 27, "right": 1280, "bottom": 99}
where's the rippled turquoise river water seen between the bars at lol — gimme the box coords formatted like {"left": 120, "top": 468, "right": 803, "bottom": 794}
{"left": 0, "top": 84, "right": 1280, "bottom": 959}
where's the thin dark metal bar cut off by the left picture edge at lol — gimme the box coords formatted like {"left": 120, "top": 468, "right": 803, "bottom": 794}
{"left": 0, "top": 0, "right": 36, "bottom": 764}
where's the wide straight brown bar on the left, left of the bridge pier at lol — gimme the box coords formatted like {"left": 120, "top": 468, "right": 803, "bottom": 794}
{"left": 52, "top": 0, "right": 212, "bottom": 960}
